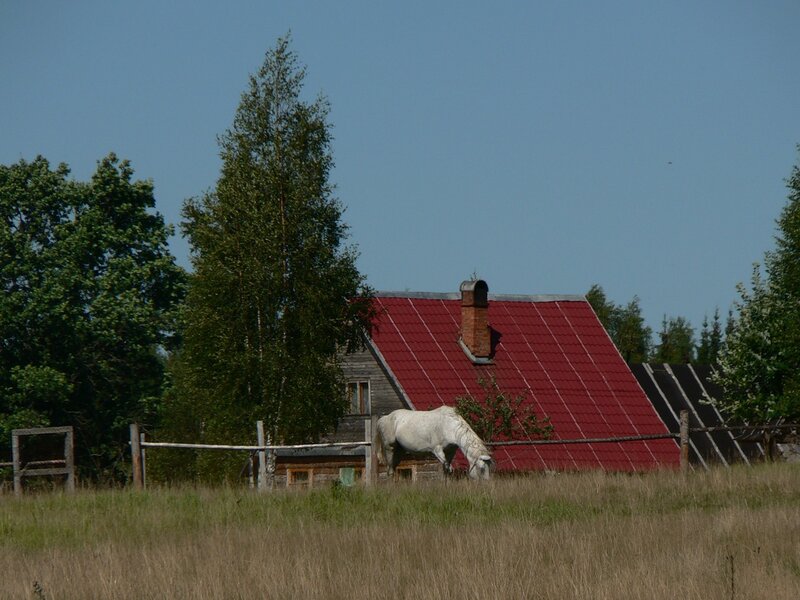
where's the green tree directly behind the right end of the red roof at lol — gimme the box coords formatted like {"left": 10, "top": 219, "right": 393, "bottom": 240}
{"left": 586, "top": 284, "right": 652, "bottom": 363}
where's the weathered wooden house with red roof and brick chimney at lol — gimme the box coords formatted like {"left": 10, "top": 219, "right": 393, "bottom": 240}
{"left": 280, "top": 280, "right": 679, "bottom": 485}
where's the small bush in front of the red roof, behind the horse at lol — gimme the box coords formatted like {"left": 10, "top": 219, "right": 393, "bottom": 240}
{"left": 456, "top": 375, "right": 553, "bottom": 442}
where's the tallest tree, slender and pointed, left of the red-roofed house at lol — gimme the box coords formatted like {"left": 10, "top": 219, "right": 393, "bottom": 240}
{"left": 161, "top": 38, "right": 371, "bottom": 480}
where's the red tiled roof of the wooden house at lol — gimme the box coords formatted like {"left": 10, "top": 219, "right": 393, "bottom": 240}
{"left": 372, "top": 294, "right": 679, "bottom": 471}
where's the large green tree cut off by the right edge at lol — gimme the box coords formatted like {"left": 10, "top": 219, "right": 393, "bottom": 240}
{"left": 715, "top": 147, "right": 800, "bottom": 423}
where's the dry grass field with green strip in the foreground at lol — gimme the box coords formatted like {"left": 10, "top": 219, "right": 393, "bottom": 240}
{"left": 0, "top": 465, "right": 800, "bottom": 600}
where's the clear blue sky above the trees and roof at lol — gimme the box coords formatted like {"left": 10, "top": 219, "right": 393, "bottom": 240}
{"left": 0, "top": 0, "right": 800, "bottom": 329}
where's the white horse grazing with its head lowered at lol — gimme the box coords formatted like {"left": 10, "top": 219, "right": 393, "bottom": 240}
{"left": 373, "top": 406, "right": 492, "bottom": 479}
